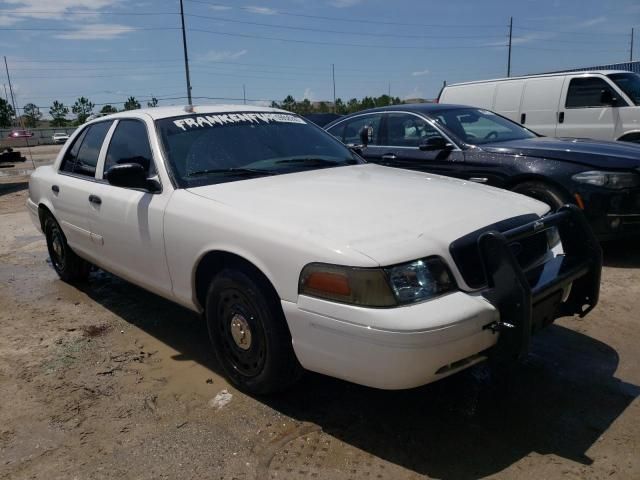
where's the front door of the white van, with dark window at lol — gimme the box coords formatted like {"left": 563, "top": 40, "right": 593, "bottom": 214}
{"left": 556, "top": 76, "right": 627, "bottom": 140}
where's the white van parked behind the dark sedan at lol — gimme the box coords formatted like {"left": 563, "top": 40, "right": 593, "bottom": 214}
{"left": 438, "top": 70, "right": 640, "bottom": 143}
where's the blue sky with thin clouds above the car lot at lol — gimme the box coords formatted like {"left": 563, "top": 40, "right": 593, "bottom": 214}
{"left": 0, "top": 0, "right": 640, "bottom": 117}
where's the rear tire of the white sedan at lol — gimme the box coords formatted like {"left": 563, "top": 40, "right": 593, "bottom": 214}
{"left": 43, "top": 215, "right": 91, "bottom": 283}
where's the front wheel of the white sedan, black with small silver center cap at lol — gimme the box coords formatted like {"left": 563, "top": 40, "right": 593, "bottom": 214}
{"left": 205, "top": 268, "right": 303, "bottom": 395}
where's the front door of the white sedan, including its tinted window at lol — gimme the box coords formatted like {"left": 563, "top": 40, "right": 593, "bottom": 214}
{"left": 89, "top": 119, "right": 172, "bottom": 295}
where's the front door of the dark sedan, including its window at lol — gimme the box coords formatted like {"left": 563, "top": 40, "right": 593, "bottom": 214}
{"left": 378, "top": 112, "right": 463, "bottom": 177}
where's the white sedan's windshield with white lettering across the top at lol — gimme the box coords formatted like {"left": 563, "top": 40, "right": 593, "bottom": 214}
{"left": 156, "top": 112, "right": 362, "bottom": 188}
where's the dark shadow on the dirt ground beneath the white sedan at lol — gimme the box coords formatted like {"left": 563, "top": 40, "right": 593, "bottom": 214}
{"left": 77, "top": 272, "right": 640, "bottom": 479}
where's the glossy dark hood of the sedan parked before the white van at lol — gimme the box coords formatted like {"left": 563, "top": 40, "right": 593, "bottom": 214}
{"left": 480, "top": 137, "right": 640, "bottom": 169}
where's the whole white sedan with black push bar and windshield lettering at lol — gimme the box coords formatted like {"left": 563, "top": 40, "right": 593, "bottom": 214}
{"left": 27, "top": 106, "right": 601, "bottom": 393}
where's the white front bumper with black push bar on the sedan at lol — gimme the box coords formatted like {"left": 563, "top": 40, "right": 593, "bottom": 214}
{"left": 282, "top": 207, "right": 602, "bottom": 389}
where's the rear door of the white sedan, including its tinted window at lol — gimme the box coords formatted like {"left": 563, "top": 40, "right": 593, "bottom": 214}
{"left": 51, "top": 121, "right": 112, "bottom": 259}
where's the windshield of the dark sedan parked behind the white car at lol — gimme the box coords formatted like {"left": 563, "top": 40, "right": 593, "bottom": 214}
{"left": 430, "top": 108, "right": 536, "bottom": 145}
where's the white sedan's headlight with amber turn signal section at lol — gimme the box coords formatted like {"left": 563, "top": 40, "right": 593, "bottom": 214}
{"left": 299, "top": 257, "right": 455, "bottom": 307}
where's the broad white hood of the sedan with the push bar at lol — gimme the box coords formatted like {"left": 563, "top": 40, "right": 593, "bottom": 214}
{"left": 188, "top": 164, "right": 548, "bottom": 265}
